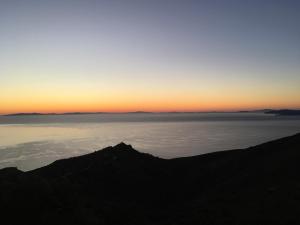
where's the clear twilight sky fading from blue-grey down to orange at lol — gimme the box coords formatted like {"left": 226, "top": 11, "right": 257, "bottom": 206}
{"left": 0, "top": 0, "right": 300, "bottom": 114}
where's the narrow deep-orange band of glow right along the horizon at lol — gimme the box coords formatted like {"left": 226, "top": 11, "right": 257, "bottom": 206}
{"left": 0, "top": 101, "right": 300, "bottom": 114}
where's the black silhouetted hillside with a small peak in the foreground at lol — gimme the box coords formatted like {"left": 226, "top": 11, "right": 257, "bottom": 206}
{"left": 0, "top": 133, "right": 300, "bottom": 225}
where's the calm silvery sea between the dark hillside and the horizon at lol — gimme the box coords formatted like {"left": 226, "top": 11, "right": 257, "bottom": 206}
{"left": 0, "top": 112, "right": 300, "bottom": 171}
